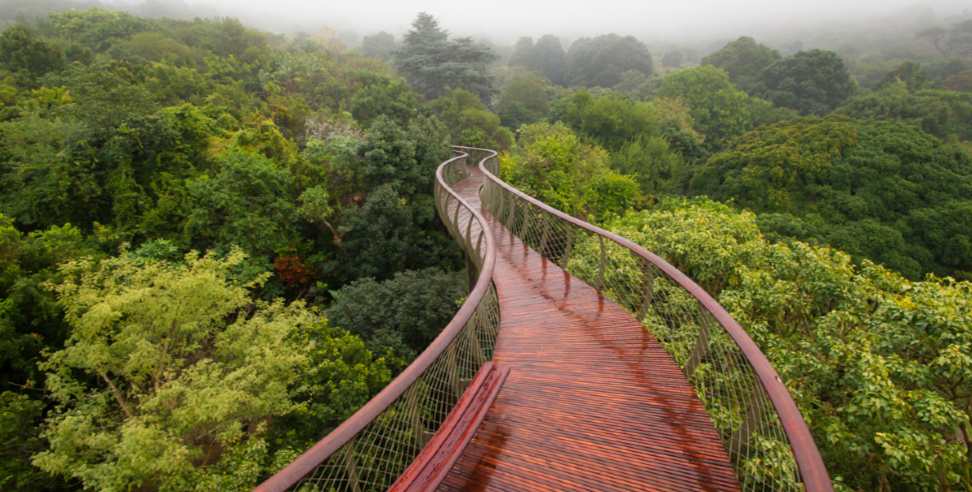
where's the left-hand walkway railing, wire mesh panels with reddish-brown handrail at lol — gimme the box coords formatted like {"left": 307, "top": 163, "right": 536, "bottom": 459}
{"left": 257, "top": 152, "right": 499, "bottom": 492}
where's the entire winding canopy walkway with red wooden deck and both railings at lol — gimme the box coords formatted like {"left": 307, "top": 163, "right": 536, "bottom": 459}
{"left": 258, "top": 147, "right": 831, "bottom": 491}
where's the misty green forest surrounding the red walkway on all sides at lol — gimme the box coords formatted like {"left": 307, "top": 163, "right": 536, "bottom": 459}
{"left": 0, "top": 0, "right": 972, "bottom": 491}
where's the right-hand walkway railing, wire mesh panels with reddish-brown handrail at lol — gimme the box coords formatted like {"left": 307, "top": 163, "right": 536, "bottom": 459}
{"left": 461, "top": 147, "right": 832, "bottom": 492}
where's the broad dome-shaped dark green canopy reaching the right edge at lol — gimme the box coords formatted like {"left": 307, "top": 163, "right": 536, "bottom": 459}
{"left": 693, "top": 117, "right": 972, "bottom": 278}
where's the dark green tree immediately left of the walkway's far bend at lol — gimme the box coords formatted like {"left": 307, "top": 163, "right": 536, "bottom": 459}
{"left": 324, "top": 116, "right": 458, "bottom": 284}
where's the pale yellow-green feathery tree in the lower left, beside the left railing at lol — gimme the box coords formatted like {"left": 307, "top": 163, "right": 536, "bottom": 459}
{"left": 34, "top": 251, "right": 388, "bottom": 490}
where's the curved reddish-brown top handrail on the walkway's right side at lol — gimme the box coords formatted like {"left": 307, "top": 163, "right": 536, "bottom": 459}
{"left": 456, "top": 147, "right": 833, "bottom": 492}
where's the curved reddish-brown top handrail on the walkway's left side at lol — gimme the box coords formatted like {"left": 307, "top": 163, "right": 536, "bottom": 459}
{"left": 255, "top": 152, "right": 496, "bottom": 492}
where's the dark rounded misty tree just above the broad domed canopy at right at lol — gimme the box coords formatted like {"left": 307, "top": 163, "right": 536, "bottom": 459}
{"left": 758, "top": 50, "right": 856, "bottom": 115}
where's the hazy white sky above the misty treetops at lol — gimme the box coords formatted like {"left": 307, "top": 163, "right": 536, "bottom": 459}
{"left": 165, "top": 0, "right": 972, "bottom": 39}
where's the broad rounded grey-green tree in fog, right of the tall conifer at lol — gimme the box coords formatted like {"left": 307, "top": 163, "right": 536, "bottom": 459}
{"left": 567, "top": 34, "right": 654, "bottom": 87}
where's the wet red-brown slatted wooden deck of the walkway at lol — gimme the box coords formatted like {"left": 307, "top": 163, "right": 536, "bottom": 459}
{"left": 439, "top": 166, "right": 739, "bottom": 490}
